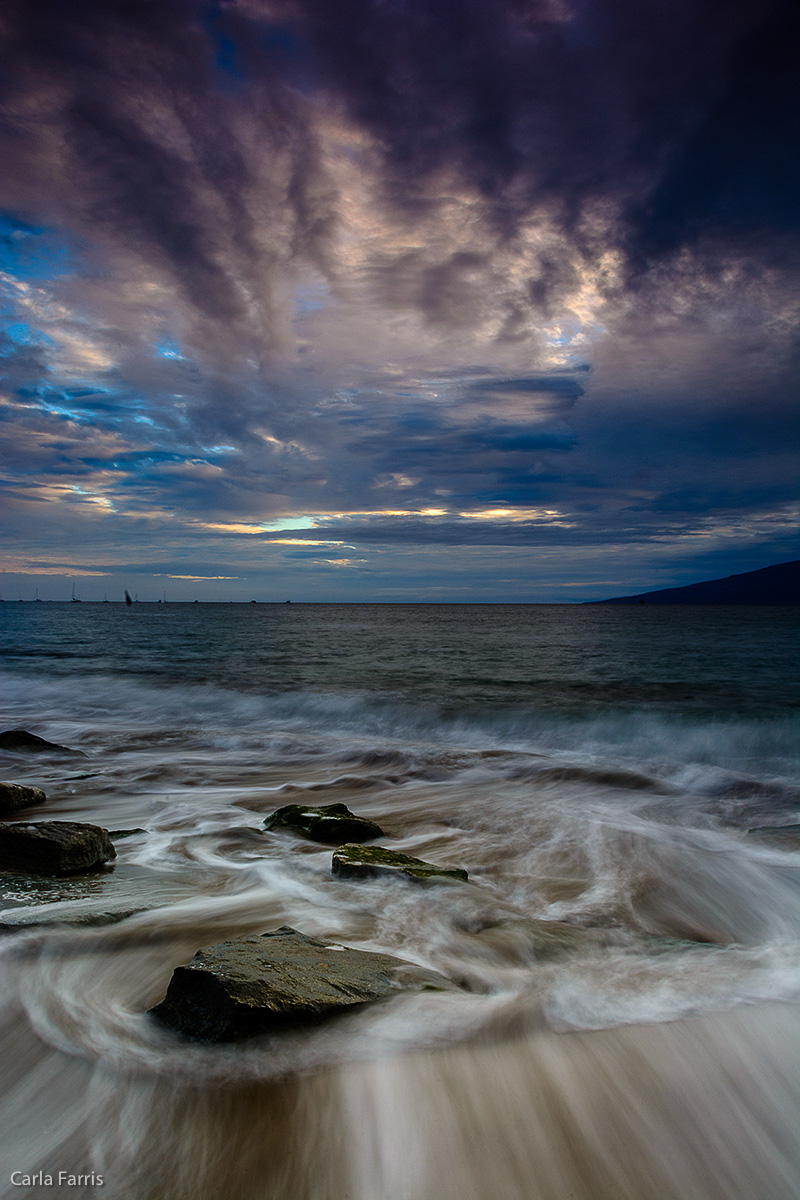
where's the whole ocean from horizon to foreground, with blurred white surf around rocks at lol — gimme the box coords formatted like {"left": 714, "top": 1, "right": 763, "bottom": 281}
{"left": 0, "top": 601, "right": 800, "bottom": 1200}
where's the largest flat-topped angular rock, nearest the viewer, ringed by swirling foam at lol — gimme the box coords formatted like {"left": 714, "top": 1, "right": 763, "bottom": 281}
{"left": 150, "top": 925, "right": 452, "bottom": 1042}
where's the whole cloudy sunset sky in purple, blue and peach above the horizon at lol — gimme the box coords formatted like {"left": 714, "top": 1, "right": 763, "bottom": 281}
{"left": 0, "top": 0, "right": 800, "bottom": 602}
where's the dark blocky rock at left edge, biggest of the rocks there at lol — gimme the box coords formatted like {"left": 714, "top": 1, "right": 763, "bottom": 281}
{"left": 0, "top": 821, "right": 116, "bottom": 875}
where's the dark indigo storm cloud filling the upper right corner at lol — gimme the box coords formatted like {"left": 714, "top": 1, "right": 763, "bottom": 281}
{"left": 293, "top": 0, "right": 800, "bottom": 265}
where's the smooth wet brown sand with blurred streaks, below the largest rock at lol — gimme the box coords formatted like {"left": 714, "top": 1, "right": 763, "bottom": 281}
{"left": 0, "top": 988, "right": 800, "bottom": 1200}
